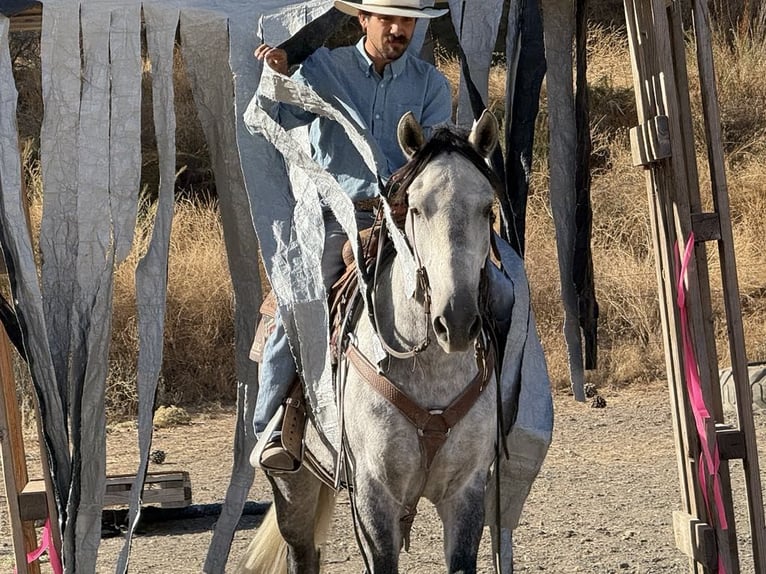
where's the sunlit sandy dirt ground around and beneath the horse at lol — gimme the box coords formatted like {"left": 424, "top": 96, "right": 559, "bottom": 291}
{"left": 0, "top": 386, "right": 766, "bottom": 574}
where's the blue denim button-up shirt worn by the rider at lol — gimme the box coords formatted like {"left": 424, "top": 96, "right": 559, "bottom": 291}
{"left": 262, "top": 38, "right": 452, "bottom": 201}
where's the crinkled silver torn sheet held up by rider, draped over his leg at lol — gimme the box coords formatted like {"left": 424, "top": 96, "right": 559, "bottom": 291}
{"left": 245, "top": 67, "right": 424, "bottom": 445}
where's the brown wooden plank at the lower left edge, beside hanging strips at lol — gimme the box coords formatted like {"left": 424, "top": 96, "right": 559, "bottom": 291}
{"left": 0, "top": 327, "right": 40, "bottom": 574}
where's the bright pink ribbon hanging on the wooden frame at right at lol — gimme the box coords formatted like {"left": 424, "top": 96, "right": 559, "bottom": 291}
{"left": 674, "top": 233, "right": 728, "bottom": 574}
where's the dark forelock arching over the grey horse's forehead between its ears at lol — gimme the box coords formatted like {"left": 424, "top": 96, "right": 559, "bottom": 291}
{"left": 387, "top": 126, "right": 502, "bottom": 206}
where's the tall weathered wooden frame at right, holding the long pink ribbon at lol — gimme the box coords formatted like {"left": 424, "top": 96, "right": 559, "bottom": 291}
{"left": 624, "top": 0, "right": 766, "bottom": 574}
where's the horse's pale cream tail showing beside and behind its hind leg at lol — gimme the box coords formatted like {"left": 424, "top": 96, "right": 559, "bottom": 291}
{"left": 235, "top": 485, "right": 335, "bottom": 574}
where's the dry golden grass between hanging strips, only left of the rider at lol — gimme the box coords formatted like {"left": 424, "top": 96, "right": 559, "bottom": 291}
{"left": 108, "top": 200, "right": 236, "bottom": 418}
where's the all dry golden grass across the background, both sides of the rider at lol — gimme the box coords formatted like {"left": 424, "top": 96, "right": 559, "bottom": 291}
{"left": 12, "top": 27, "right": 766, "bottom": 414}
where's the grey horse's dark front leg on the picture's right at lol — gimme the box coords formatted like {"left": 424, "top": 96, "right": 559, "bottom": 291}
{"left": 436, "top": 478, "right": 484, "bottom": 574}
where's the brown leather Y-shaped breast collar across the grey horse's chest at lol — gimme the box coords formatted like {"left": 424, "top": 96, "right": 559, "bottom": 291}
{"left": 346, "top": 343, "right": 494, "bottom": 470}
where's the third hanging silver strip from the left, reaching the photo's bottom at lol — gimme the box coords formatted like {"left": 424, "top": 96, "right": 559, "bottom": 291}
{"left": 67, "top": 0, "right": 114, "bottom": 572}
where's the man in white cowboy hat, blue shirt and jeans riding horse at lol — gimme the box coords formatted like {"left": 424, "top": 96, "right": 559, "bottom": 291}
{"left": 254, "top": 0, "right": 452, "bottom": 471}
